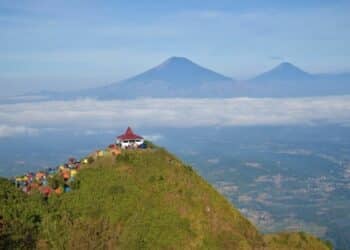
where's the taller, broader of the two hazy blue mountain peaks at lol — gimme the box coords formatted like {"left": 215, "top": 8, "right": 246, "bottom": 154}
{"left": 93, "top": 57, "right": 235, "bottom": 99}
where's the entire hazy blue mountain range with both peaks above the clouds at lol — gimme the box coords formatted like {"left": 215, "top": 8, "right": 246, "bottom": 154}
{"left": 8, "top": 56, "right": 350, "bottom": 102}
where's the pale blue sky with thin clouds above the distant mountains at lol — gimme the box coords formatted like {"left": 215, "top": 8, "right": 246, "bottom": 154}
{"left": 0, "top": 0, "right": 350, "bottom": 93}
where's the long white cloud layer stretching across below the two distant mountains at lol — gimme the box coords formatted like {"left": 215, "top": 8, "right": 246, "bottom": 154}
{"left": 0, "top": 96, "right": 350, "bottom": 137}
